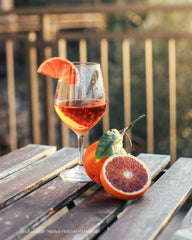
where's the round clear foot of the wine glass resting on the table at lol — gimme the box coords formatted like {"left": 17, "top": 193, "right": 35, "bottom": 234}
{"left": 60, "top": 165, "right": 92, "bottom": 182}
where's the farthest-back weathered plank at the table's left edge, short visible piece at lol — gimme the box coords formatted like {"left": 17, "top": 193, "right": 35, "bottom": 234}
{"left": 0, "top": 144, "right": 56, "bottom": 179}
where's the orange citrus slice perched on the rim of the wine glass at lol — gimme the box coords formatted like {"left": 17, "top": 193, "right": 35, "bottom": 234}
{"left": 37, "top": 57, "right": 79, "bottom": 86}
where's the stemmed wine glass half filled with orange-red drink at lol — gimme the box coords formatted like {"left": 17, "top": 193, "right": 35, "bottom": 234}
{"left": 54, "top": 62, "right": 107, "bottom": 182}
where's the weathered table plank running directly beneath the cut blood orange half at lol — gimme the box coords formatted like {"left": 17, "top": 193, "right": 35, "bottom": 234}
{"left": 28, "top": 154, "right": 170, "bottom": 240}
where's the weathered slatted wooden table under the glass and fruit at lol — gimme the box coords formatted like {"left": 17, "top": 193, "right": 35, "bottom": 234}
{"left": 0, "top": 145, "right": 192, "bottom": 240}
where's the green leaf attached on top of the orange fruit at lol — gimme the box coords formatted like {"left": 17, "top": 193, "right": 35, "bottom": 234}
{"left": 96, "top": 129, "right": 123, "bottom": 162}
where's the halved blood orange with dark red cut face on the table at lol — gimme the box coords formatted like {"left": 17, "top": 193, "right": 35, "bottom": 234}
{"left": 100, "top": 154, "right": 151, "bottom": 200}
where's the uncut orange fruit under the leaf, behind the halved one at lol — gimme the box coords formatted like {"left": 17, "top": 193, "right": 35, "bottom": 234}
{"left": 83, "top": 141, "right": 127, "bottom": 184}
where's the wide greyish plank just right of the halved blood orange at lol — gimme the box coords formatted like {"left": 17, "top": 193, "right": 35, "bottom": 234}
{"left": 99, "top": 158, "right": 192, "bottom": 240}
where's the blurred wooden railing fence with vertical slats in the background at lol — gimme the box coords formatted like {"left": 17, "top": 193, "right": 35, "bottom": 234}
{"left": 0, "top": 5, "right": 192, "bottom": 161}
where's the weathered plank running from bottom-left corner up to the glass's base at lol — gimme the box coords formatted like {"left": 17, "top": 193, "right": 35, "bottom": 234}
{"left": 0, "top": 177, "right": 93, "bottom": 240}
